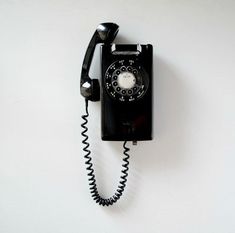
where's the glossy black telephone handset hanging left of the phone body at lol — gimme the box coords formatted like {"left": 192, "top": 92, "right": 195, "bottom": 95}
{"left": 80, "top": 23, "right": 119, "bottom": 101}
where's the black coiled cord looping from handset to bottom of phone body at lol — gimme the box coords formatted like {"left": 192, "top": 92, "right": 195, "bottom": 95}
{"left": 81, "top": 100, "right": 130, "bottom": 206}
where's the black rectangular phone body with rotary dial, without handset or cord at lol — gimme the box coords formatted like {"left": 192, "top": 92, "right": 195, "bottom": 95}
{"left": 100, "top": 44, "right": 153, "bottom": 141}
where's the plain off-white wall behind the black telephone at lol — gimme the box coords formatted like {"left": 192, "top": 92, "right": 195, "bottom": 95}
{"left": 0, "top": 0, "right": 235, "bottom": 233}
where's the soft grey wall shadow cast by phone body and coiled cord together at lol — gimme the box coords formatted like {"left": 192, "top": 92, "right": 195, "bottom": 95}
{"left": 103, "top": 53, "right": 193, "bottom": 213}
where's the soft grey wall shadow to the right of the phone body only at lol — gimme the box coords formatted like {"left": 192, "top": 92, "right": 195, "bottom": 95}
{"left": 135, "top": 56, "right": 189, "bottom": 172}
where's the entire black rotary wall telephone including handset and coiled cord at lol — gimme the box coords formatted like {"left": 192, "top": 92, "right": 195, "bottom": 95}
{"left": 80, "top": 23, "right": 153, "bottom": 206}
